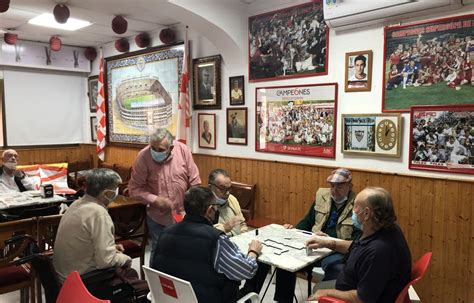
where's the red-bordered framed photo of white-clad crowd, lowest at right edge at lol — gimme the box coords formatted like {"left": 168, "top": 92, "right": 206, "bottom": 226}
{"left": 408, "top": 104, "right": 474, "bottom": 174}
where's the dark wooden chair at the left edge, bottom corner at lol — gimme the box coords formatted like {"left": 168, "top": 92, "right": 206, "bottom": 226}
{"left": 0, "top": 218, "right": 36, "bottom": 303}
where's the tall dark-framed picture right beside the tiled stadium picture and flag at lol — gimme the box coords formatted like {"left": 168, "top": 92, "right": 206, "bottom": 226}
{"left": 193, "top": 55, "right": 221, "bottom": 109}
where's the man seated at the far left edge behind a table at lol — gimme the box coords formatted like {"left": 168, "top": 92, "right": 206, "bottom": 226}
{"left": 0, "top": 149, "right": 35, "bottom": 192}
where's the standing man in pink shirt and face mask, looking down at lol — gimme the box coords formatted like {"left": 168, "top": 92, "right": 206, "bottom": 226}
{"left": 128, "top": 129, "right": 201, "bottom": 264}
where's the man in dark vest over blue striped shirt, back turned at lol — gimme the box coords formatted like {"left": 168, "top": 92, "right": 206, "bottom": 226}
{"left": 151, "top": 187, "right": 262, "bottom": 303}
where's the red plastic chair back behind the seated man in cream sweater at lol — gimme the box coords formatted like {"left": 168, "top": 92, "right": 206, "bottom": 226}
{"left": 56, "top": 271, "right": 110, "bottom": 303}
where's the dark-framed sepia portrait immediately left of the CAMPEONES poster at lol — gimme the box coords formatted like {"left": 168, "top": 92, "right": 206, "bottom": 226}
{"left": 227, "top": 107, "right": 247, "bottom": 145}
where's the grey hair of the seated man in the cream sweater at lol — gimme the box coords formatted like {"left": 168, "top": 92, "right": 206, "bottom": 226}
{"left": 86, "top": 168, "right": 122, "bottom": 197}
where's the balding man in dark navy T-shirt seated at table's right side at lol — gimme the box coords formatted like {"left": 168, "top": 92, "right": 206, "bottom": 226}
{"left": 307, "top": 187, "right": 411, "bottom": 302}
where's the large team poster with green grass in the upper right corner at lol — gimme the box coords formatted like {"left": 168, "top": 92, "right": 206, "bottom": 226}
{"left": 382, "top": 14, "right": 474, "bottom": 112}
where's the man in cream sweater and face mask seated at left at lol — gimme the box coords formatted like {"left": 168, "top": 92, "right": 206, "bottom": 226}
{"left": 53, "top": 168, "right": 146, "bottom": 302}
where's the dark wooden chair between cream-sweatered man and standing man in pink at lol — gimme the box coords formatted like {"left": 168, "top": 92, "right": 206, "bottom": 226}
{"left": 109, "top": 204, "right": 148, "bottom": 279}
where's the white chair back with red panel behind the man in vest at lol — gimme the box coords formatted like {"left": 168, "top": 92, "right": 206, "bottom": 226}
{"left": 143, "top": 266, "right": 198, "bottom": 303}
